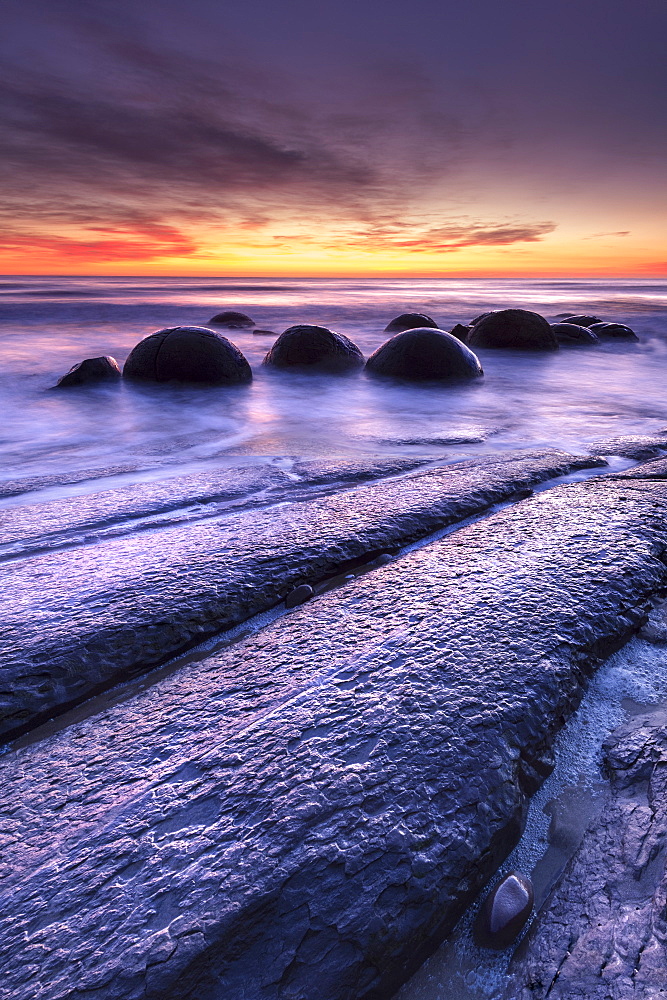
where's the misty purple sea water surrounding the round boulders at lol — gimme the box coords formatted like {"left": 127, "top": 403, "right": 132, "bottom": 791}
{"left": 0, "top": 277, "right": 667, "bottom": 492}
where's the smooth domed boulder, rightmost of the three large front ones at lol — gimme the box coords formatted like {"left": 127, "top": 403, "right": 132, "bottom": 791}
{"left": 366, "top": 327, "right": 484, "bottom": 381}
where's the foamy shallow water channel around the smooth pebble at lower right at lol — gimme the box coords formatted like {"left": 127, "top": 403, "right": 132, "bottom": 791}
{"left": 395, "top": 638, "right": 667, "bottom": 1000}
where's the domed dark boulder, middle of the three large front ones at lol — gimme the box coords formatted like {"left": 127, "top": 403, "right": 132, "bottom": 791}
{"left": 262, "top": 323, "right": 364, "bottom": 372}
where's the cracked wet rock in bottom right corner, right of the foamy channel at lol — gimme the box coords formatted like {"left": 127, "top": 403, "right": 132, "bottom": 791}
{"left": 504, "top": 710, "right": 667, "bottom": 1000}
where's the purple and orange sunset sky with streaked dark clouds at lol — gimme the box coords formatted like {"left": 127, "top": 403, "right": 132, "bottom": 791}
{"left": 0, "top": 0, "right": 667, "bottom": 277}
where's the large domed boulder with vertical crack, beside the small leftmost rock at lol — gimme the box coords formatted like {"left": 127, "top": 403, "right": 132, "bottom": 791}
{"left": 123, "top": 326, "right": 252, "bottom": 385}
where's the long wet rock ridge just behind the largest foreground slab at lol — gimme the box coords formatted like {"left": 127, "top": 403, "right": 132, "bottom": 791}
{"left": 0, "top": 450, "right": 599, "bottom": 736}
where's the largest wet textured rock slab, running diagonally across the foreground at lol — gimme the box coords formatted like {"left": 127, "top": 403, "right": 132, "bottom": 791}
{"left": 0, "top": 480, "right": 667, "bottom": 1000}
